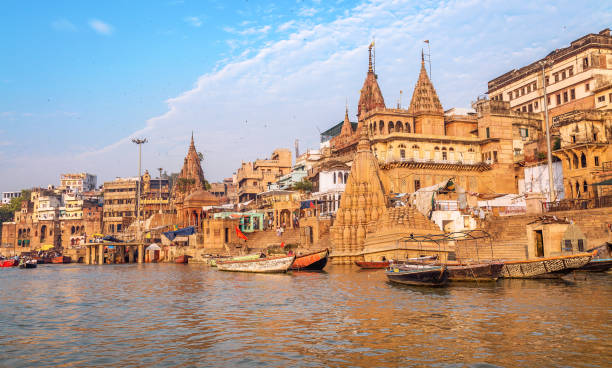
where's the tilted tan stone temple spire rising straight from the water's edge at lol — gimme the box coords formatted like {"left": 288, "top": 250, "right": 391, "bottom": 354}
{"left": 330, "top": 129, "right": 388, "bottom": 263}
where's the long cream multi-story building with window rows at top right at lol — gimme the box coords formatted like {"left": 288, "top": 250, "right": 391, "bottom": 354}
{"left": 488, "top": 28, "right": 612, "bottom": 122}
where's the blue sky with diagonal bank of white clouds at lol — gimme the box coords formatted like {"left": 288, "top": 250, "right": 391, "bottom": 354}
{"left": 0, "top": 0, "right": 612, "bottom": 191}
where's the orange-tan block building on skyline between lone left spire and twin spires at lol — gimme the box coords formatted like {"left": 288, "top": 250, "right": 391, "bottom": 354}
{"left": 236, "top": 148, "right": 291, "bottom": 202}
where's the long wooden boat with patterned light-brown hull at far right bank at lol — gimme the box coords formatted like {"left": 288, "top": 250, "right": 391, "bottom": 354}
{"left": 501, "top": 253, "right": 593, "bottom": 279}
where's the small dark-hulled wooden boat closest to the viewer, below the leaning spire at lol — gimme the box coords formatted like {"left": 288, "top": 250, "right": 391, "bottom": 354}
{"left": 386, "top": 265, "right": 449, "bottom": 286}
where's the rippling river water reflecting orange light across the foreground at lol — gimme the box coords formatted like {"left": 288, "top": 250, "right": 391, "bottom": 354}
{"left": 0, "top": 264, "right": 612, "bottom": 367}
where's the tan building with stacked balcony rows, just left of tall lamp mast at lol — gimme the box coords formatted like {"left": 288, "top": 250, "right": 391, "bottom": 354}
{"left": 103, "top": 178, "right": 139, "bottom": 234}
